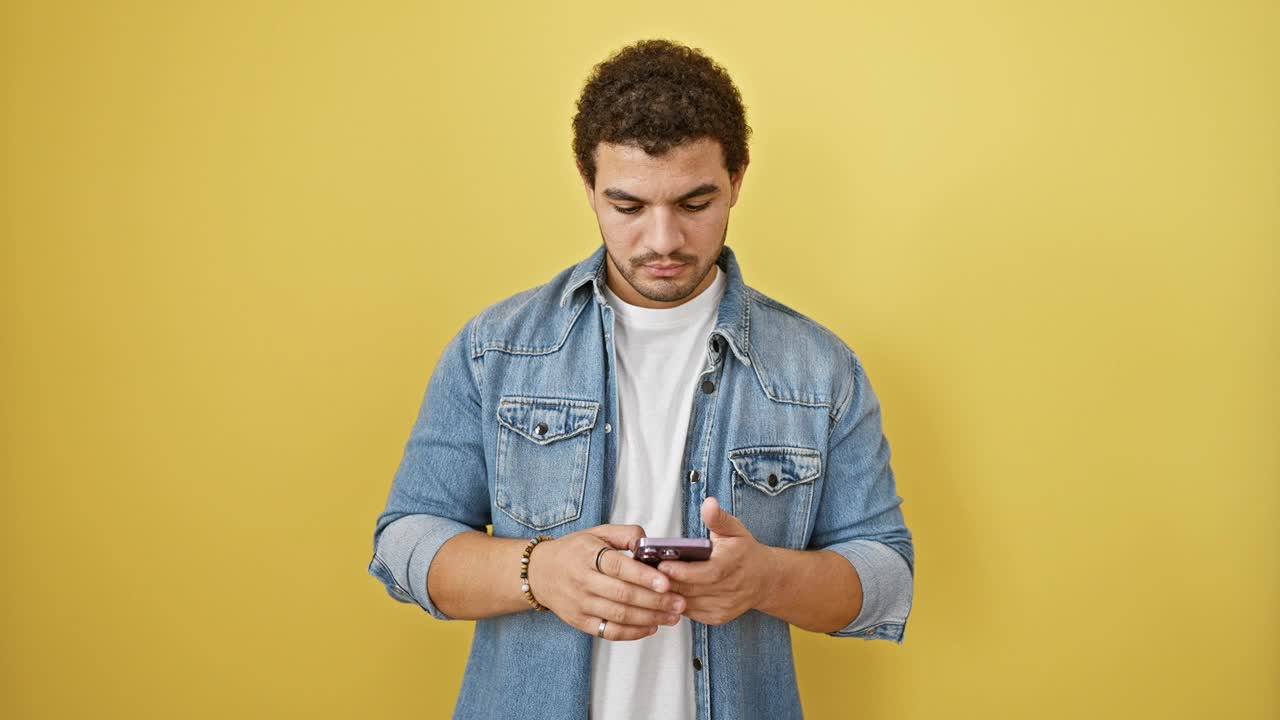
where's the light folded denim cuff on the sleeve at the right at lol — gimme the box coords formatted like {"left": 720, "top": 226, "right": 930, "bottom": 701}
{"left": 823, "top": 539, "right": 914, "bottom": 644}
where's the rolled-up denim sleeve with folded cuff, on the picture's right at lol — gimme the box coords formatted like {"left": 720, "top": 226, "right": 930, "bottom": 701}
{"left": 809, "top": 351, "right": 915, "bottom": 643}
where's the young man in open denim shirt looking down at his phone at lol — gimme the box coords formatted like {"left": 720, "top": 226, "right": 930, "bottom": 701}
{"left": 369, "top": 41, "right": 914, "bottom": 720}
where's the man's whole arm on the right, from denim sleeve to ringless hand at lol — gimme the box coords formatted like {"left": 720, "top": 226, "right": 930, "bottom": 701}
{"left": 658, "top": 354, "right": 914, "bottom": 642}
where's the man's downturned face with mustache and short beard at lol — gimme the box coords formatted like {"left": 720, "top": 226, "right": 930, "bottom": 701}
{"left": 584, "top": 138, "right": 746, "bottom": 307}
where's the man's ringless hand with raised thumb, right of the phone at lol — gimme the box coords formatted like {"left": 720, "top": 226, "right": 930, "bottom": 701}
{"left": 658, "top": 497, "right": 773, "bottom": 625}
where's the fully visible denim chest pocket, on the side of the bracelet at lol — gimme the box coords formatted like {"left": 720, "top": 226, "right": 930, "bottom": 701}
{"left": 494, "top": 397, "right": 600, "bottom": 530}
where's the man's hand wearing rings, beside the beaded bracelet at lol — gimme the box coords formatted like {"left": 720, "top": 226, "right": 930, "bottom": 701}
{"left": 529, "top": 525, "right": 685, "bottom": 641}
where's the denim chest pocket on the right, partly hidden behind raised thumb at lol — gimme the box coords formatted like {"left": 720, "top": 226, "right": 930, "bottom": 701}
{"left": 728, "top": 447, "right": 822, "bottom": 550}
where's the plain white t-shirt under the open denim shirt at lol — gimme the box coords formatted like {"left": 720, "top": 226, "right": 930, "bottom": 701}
{"left": 590, "top": 266, "right": 724, "bottom": 720}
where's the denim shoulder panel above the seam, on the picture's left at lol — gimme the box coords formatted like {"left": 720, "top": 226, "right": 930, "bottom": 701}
{"left": 470, "top": 258, "right": 586, "bottom": 356}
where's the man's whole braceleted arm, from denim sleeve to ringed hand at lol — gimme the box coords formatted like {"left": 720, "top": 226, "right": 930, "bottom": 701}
{"left": 369, "top": 316, "right": 685, "bottom": 639}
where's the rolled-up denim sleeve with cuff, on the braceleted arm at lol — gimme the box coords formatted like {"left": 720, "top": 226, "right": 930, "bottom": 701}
{"left": 369, "top": 317, "right": 490, "bottom": 620}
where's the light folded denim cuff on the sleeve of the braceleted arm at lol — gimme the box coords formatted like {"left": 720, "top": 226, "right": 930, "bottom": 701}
{"left": 369, "top": 515, "right": 475, "bottom": 620}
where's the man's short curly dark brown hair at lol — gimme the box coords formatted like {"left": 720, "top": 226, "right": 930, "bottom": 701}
{"left": 573, "top": 40, "right": 751, "bottom": 187}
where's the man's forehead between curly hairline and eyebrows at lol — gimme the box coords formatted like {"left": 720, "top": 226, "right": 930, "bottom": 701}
{"left": 595, "top": 138, "right": 728, "bottom": 195}
